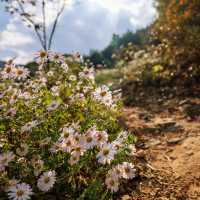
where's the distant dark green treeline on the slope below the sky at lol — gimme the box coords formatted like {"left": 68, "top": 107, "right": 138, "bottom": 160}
{"left": 84, "top": 27, "right": 149, "bottom": 67}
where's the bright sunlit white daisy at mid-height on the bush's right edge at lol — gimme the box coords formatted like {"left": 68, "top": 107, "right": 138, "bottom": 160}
{"left": 93, "top": 85, "right": 113, "bottom": 106}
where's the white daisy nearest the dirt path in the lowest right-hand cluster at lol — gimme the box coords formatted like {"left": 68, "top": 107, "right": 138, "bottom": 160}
{"left": 121, "top": 162, "right": 136, "bottom": 179}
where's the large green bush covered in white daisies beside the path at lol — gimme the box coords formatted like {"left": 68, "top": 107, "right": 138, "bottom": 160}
{"left": 0, "top": 51, "right": 135, "bottom": 200}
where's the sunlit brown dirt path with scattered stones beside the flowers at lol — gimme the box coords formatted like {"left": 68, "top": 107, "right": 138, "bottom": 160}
{"left": 120, "top": 99, "right": 200, "bottom": 200}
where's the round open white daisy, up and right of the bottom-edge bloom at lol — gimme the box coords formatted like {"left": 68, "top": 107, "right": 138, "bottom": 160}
{"left": 37, "top": 171, "right": 56, "bottom": 192}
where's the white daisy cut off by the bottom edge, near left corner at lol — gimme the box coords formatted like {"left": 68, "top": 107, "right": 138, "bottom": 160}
{"left": 8, "top": 183, "right": 33, "bottom": 200}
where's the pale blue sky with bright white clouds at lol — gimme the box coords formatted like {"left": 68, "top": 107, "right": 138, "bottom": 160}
{"left": 0, "top": 0, "right": 156, "bottom": 64}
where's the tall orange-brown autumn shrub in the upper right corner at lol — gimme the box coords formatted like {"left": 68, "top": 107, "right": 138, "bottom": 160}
{"left": 152, "top": 0, "right": 200, "bottom": 84}
